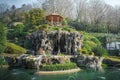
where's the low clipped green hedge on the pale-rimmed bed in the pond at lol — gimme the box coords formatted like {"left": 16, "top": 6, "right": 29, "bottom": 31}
{"left": 40, "top": 63, "right": 77, "bottom": 71}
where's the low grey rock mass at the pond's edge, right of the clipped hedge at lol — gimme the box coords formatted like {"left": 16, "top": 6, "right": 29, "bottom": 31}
{"left": 76, "top": 54, "right": 103, "bottom": 71}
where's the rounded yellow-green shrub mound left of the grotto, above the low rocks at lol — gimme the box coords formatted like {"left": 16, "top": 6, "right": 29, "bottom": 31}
{"left": 5, "top": 42, "right": 27, "bottom": 54}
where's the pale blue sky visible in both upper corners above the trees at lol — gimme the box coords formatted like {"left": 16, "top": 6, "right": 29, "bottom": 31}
{"left": 0, "top": 0, "right": 120, "bottom": 7}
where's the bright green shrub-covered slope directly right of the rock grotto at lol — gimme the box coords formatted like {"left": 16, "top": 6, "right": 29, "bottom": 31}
{"left": 82, "top": 33, "right": 108, "bottom": 56}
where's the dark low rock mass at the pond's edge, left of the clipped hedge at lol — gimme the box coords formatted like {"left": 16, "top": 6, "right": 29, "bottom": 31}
{"left": 5, "top": 54, "right": 44, "bottom": 69}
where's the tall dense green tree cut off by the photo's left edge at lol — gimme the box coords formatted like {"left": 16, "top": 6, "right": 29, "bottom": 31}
{"left": 0, "top": 23, "right": 7, "bottom": 53}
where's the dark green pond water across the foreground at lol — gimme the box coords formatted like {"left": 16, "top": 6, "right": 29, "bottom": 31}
{"left": 0, "top": 68, "right": 120, "bottom": 80}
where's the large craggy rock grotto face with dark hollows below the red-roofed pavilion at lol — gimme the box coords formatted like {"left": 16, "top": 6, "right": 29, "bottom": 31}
{"left": 27, "top": 30, "right": 83, "bottom": 55}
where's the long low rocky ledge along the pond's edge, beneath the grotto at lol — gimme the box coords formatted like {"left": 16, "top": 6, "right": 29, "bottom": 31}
{"left": 4, "top": 54, "right": 103, "bottom": 71}
